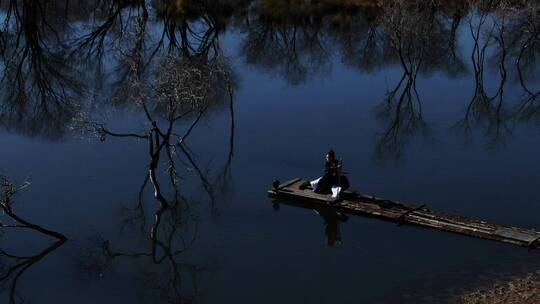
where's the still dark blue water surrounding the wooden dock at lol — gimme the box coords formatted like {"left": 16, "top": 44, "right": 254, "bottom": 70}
{"left": 0, "top": 1, "right": 540, "bottom": 303}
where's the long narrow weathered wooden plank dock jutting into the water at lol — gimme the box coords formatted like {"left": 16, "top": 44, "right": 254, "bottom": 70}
{"left": 268, "top": 178, "right": 540, "bottom": 249}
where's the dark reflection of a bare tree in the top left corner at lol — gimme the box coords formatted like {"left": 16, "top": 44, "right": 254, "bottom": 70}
{"left": 0, "top": 0, "right": 84, "bottom": 139}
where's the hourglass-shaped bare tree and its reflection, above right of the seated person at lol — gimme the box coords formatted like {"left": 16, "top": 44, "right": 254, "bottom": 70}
{"left": 376, "top": 1, "right": 436, "bottom": 163}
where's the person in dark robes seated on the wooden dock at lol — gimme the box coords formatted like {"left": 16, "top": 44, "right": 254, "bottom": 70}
{"left": 310, "top": 150, "right": 349, "bottom": 198}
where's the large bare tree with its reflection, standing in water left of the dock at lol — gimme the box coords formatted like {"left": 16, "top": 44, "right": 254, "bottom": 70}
{"left": 77, "top": 57, "right": 234, "bottom": 303}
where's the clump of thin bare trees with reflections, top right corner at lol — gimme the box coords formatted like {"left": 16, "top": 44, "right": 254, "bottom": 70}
{"left": 458, "top": 2, "right": 539, "bottom": 147}
